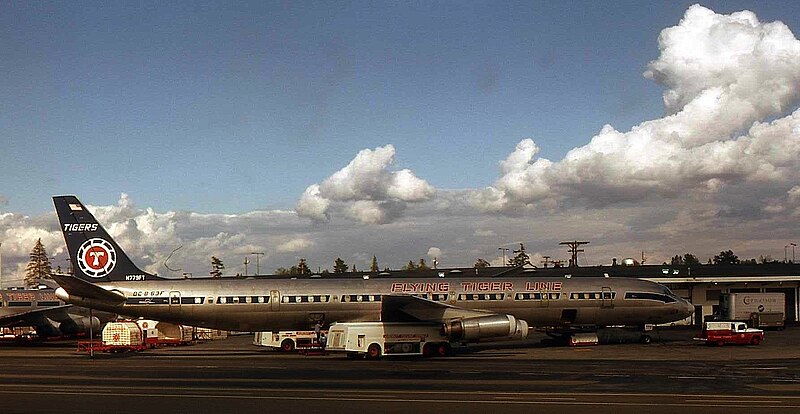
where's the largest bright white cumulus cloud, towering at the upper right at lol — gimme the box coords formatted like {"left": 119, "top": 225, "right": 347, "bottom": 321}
{"left": 469, "top": 5, "right": 800, "bottom": 212}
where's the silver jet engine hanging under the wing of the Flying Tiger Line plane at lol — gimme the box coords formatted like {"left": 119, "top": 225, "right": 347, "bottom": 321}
{"left": 444, "top": 315, "right": 528, "bottom": 341}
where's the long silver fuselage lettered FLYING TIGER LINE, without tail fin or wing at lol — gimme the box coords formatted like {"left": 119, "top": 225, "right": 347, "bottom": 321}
{"left": 58, "top": 277, "right": 693, "bottom": 331}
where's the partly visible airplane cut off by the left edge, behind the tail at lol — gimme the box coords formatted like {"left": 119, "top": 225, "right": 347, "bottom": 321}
{"left": 0, "top": 285, "right": 110, "bottom": 339}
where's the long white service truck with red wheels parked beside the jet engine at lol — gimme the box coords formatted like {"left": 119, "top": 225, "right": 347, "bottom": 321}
{"left": 325, "top": 322, "right": 450, "bottom": 359}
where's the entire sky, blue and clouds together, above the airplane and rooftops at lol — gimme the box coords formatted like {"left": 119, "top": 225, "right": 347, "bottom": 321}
{"left": 0, "top": 1, "right": 800, "bottom": 280}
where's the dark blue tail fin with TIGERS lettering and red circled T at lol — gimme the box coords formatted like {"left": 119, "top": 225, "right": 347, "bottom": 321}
{"left": 53, "top": 196, "right": 160, "bottom": 282}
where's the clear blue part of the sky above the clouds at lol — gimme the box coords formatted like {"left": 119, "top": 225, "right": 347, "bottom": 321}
{"left": 0, "top": 2, "right": 798, "bottom": 214}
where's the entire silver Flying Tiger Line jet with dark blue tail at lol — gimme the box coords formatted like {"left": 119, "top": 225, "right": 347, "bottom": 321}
{"left": 53, "top": 195, "right": 694, "bottom": 342}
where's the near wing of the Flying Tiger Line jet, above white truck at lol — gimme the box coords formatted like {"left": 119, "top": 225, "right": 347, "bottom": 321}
{"left": 381, "top": 295, "right": 496, "bottom": 323}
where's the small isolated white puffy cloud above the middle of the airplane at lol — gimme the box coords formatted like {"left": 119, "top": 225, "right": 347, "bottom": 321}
{"left": 297, "top": 144, "right": 436, "bottom": 224}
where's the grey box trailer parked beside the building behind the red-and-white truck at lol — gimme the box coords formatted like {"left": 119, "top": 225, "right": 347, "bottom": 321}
{"left": 719, "top": 293, "right": 786, "bottom": 328}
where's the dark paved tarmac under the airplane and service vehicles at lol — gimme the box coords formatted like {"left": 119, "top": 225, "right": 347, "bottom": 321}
{"left": 0, "top": 327, "right": 800, "bottom": 414}
